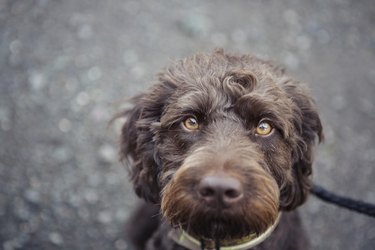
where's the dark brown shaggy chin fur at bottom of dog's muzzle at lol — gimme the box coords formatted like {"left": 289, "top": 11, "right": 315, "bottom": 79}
{"left": 164, "top": 196, "right": 278, "bottom": 241}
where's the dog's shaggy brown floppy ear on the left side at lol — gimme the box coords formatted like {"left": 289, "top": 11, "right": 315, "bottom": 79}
{"left": 119, "top": 78, "right": 179, "bottom": 203}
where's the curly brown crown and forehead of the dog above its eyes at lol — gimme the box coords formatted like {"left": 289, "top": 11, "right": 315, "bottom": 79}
{"left": 159, "top": 53, "right": 302, "bottom": 131}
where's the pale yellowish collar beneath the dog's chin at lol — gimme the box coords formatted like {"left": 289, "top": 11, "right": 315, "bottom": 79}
{"left": 168, "top": 213, "right": 281, "bottom": 250}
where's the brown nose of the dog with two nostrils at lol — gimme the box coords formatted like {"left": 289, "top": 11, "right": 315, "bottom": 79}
{"left": 198, "top": 175, "right": 243, "bottom": 208}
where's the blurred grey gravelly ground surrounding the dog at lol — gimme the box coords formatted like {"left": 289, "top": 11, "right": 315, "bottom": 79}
{"left": 0, "top": 0, "right": 375, "bottom": 250}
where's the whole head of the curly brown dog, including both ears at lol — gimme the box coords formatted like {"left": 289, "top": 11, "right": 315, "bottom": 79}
{"left": 121, "top": 51, "right": 323, "bottom": 239}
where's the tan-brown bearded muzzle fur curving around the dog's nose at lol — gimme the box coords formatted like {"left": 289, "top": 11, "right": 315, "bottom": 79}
{"left": 161, "top": 167, "right": 279, "bottom": 240}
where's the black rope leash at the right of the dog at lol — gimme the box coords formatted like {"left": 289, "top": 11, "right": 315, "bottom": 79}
{"left": 310, "top": 185, "right": 375, "bottom": 217}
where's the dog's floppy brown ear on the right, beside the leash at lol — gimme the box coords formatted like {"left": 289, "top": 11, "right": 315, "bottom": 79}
{"left": 280, "top": 82, "right": 324, "bottom": 210}
